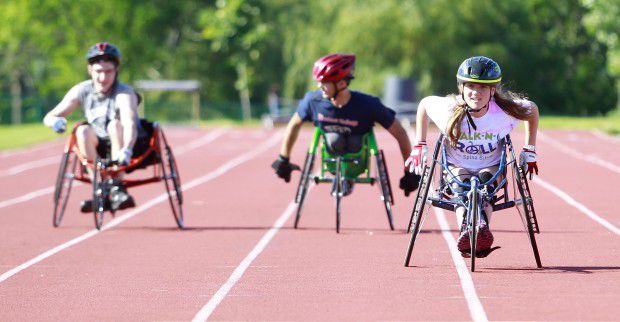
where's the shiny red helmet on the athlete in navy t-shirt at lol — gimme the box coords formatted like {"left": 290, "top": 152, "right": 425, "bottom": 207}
{"left": 312, "top": 54, "right": 355, "bottom": 82}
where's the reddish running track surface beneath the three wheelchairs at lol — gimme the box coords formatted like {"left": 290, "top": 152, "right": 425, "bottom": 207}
{"left": 0, "top": 128, "right": 620, "bottom": 321}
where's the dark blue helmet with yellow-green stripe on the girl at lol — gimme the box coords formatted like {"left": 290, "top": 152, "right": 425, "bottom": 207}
{"left": 456, "top": 56, "right": 502, "bottom": 85}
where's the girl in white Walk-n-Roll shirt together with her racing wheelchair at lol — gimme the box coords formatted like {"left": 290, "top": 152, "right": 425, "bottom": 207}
{"left": 405, "top": 56, "right": 540, "bottom": 269}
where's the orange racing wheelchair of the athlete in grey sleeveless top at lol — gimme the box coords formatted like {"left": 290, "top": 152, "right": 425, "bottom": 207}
{"left": 53, "top": 119, "right": 183, "bottom": 230}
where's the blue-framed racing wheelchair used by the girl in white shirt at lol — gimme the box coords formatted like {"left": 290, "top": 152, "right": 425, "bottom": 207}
{"left": 405, "top": 134, "right": 542, "bottom": 272}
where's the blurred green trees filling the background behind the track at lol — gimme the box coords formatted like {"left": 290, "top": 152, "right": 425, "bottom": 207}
{"left": 0, "top": 0, "right": 620, "bottom": 122}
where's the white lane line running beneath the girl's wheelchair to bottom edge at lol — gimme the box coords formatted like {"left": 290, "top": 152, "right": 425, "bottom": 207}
{"left": 434, "top": 207, "right": 489, "bottom": 322}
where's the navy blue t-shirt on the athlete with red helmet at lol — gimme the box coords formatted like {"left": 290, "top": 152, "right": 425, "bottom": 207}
{"left": 297, "top": 90, "right": 396, "bottom": 135}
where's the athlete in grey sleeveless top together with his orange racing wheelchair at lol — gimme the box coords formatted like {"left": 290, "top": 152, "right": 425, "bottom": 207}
{"left": 43, "top": 43, "right": 182, "bottom": 228}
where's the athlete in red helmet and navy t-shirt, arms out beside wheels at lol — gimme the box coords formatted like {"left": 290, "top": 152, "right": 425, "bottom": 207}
{"left": 272, "top": 54, "right": 419, "bottom": 231}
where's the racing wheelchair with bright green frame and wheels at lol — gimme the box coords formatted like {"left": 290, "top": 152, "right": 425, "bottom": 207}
{"left": 294, "top": 128, "right": 394, "bottom": 233}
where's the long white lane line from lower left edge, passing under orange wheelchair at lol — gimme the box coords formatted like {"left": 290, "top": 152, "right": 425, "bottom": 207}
{"left": 0, "top": 132, "right": 280, "bottom": 283}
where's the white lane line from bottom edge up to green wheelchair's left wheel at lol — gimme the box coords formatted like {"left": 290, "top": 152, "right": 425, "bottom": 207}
{"left": 192, "top": 196, "right": 302, "bottom": 321}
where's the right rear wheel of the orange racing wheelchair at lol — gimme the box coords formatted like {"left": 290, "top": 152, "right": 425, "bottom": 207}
{"left": 159, "top": 132, "right": 184, "bottom": 229}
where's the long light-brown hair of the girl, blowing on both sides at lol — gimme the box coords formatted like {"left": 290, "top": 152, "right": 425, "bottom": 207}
{"left": 446, "top": 86, "right": 531, "bottom": 147}
